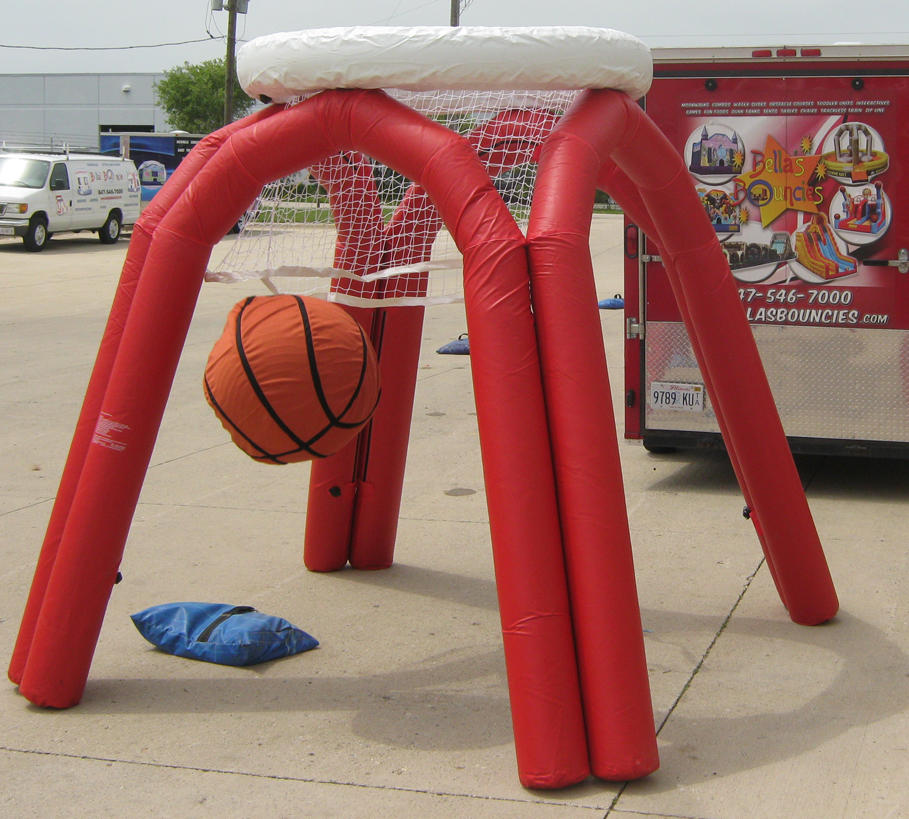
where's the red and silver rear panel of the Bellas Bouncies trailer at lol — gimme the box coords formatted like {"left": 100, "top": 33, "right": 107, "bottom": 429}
{"left": 626, "top": 58, "right": 909, "bottom": 454}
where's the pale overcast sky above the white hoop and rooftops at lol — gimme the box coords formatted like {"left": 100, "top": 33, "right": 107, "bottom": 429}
{"left": 0, "top": 0, "right": 909, "bottom": 74}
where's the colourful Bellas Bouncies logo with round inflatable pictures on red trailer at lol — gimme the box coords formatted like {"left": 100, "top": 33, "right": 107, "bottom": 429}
{"left": 684, "top": 116, "right": 892, "bottom": 284}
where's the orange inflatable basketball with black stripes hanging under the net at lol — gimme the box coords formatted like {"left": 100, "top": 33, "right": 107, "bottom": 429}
{"left": 204, "top": 295, "right": 380, "bottom": 464}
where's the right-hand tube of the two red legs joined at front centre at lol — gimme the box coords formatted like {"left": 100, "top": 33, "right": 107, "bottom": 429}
{"left": 527, "top": 100, "right": 659, "bottom": 780}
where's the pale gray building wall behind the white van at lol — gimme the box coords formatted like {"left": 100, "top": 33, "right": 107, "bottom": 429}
{"left": 0, "top": 74, "right": 170, "bottom": 149}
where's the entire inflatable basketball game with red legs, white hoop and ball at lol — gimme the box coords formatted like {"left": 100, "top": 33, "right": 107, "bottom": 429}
{"left": 9, "top": 27, "right": 838, "bottom": 788}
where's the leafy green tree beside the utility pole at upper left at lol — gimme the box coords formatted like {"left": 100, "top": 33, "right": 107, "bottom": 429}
{"left": 155, "top": 59, "right": 255, "bottom": 134}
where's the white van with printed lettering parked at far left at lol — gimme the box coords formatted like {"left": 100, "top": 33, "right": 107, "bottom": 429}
{"left": 0, "top": 151, "right": 140, "bottom": 250}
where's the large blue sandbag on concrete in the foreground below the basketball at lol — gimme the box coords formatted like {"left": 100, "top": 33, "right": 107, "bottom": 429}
{"left": 131, "top": 603, "right": 319, "bottom": 665}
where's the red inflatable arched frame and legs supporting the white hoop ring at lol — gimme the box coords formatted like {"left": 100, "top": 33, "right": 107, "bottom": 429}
{"left": 9, "top": 83, "right": 838, "bottom": 788}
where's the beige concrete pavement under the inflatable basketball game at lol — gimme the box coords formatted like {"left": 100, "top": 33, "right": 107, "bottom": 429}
{"left": 0, "top": 217, "right": 909, "bottom": 819}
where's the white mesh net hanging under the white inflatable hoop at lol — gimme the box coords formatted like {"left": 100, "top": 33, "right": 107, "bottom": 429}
{"left": 206, "top": 89, "right": 578, "bottom": 306}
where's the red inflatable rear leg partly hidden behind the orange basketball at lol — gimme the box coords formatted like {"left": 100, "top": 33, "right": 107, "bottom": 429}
{"left": 303, "top": 153, "right": 424, "bottom": 571}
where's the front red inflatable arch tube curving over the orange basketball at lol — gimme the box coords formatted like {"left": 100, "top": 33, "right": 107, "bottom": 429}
{"left": 12, "top": 91, "right": 589, "bottom": 788}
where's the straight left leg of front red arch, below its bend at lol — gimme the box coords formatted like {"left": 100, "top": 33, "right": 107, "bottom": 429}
{"left": 19, "top": 238, "right": 211, "bottom": 708}
